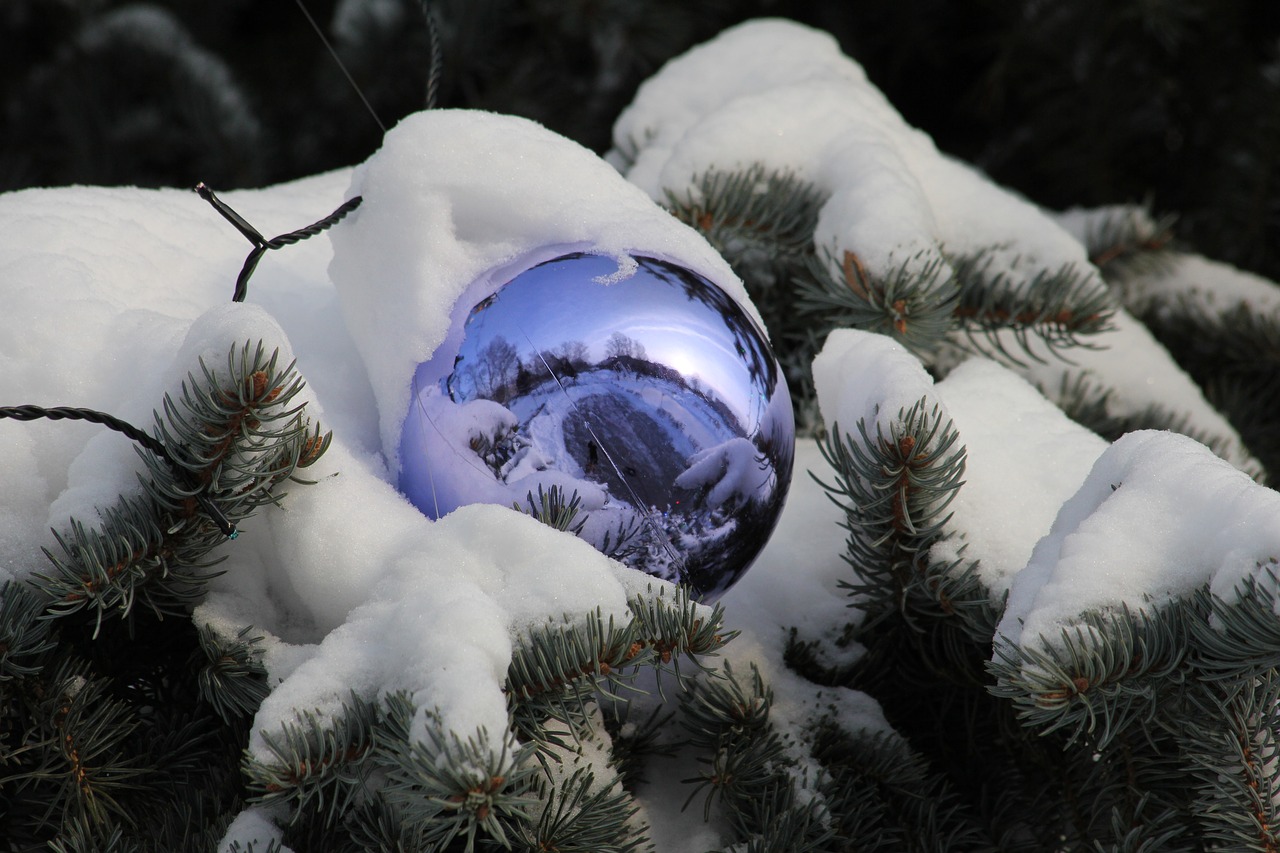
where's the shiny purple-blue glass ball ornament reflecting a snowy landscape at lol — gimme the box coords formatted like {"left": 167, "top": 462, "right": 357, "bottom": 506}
{"left": 399, "top": 254, "right": 795, "bottom": 599}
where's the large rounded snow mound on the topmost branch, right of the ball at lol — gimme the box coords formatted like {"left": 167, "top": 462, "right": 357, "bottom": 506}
{"left": 608, "top": 19, "right": 1103, "bottom": 295}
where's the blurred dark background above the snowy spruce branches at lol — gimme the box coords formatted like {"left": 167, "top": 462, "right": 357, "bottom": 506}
{"left": 0, "top": 0, "right": 1280, "bottom": 278}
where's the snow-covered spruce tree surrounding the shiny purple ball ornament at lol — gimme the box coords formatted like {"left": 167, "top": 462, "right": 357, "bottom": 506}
{"left": 0, "top": 11, "right": 1280, "bottom": 853}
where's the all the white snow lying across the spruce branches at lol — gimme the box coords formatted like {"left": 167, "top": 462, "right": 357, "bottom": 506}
{"left": 0, "top": 18, "right": 1280, "bottom": 853}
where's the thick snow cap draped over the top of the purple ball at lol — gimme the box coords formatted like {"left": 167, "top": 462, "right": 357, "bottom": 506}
{"left": 329, "top": 110, "right": 763, "bottom": 471}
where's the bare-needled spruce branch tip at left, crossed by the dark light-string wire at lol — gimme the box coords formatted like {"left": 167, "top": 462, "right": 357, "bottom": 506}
{"left": 29, "top": 343, "right": 330, "bottom": 626}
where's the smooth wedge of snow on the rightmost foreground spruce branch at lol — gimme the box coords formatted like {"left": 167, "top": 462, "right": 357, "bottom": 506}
{"left": 997, "top": 430, "right": 1280, "bottom": 647}
